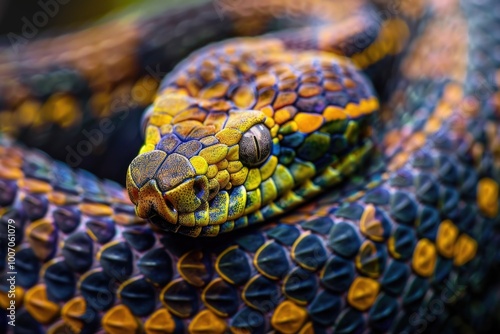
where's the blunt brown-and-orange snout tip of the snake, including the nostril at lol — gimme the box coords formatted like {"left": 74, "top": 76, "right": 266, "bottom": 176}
{"left": 127, "top": 150, "right": 210, "bottom": 224}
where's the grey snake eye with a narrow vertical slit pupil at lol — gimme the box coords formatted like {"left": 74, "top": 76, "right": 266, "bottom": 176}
{"left": 240, "top": 124, "right": 273, "bottom": 167}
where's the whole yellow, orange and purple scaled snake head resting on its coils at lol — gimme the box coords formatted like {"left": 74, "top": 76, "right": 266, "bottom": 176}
{"left": 127, "top": 39, "right": 378, "bottom": 236}
